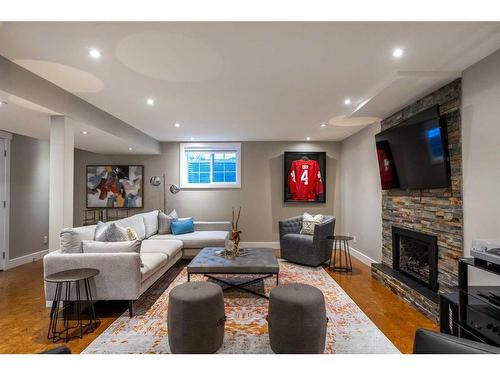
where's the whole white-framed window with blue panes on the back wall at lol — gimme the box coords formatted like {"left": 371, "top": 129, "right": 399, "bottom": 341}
{"left": 179, "top": 143, "right": 241, "bottom": 189}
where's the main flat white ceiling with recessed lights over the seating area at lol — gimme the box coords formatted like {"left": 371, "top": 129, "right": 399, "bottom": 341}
{"left": 0, "top": 22, "right": 500, "bottom": 149}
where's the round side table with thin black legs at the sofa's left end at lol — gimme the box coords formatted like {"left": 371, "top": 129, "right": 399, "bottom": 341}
{"left": 45, "top": 268, "right": 99, "bottom": 342}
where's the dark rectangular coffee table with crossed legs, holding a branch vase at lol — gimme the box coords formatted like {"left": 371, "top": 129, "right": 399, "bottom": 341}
{"left": 187, "top": 247, "right": 280, "bottom": 299}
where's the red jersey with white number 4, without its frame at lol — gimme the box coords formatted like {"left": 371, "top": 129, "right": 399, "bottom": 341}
{"left": 288, "top": 159, "right": 323, "bottom": 201}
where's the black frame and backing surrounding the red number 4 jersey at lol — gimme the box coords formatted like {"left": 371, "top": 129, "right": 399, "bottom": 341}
{"left": 283, "top": 151, "right": 326, "bottom": 204}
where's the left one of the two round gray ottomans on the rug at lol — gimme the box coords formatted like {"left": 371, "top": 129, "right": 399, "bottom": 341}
{"left": 167, "top": 282, "right": 226, "bottom": 354}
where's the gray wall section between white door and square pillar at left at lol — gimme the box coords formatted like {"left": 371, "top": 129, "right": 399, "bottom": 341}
{"left": 9, "top": 134, "right": 49, "bottom": 259}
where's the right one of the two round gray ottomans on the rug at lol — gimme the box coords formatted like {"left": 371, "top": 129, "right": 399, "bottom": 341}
{"left": 268, "top": 284, "right": 327, "bottom": 354}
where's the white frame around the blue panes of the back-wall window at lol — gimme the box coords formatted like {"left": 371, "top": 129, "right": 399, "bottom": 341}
{"left": 179, "top": 143, "right": 241, "bottom": 189}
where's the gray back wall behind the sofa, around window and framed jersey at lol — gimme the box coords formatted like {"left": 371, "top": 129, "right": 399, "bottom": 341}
{"left": 74, "top": 142, "right": 340, "bottom": 242}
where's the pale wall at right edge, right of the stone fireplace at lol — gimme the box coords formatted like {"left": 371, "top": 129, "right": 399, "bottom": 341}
{"left": 462, "top": 50, "right": 500, "bottom": 284}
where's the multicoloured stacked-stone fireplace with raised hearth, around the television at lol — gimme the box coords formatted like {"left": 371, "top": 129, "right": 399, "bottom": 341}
{"left": 372, "top": 79, "right": 463, "bottom": 321}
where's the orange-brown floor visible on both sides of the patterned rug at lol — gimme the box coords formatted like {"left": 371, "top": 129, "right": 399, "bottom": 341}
{"left": 0, "top": 258, "right": 437, "bottom": 353}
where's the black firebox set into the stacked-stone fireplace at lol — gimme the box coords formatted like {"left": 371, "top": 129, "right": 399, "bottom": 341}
{"left": 392, "top": 227, "right": 438, "bottom": 292}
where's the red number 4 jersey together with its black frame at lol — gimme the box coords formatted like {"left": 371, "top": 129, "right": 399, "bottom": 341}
{"left": 284, "top": 152, "right": 326, "bottom": 203}
